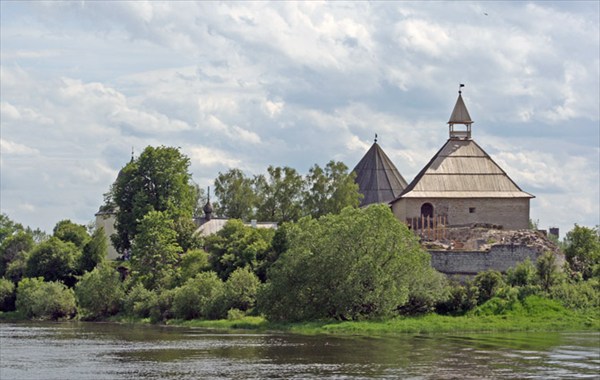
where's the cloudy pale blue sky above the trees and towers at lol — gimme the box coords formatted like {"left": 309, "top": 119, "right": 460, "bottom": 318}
{"left": 0, "top": 1, "right": 600, "bottom": 236}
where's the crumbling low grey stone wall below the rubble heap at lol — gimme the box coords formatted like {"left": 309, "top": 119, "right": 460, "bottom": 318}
{"left": 429, "top": 244, "right": 564, "bottom": 275}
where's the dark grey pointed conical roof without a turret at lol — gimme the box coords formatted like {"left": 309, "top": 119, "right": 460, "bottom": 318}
{"left": 353, "top": 142, "right": 407, "bottom": 207}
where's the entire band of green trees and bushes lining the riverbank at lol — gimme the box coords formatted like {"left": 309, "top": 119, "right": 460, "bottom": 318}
{"left": 0, "top": 147, "right": 600, "bottom": 322}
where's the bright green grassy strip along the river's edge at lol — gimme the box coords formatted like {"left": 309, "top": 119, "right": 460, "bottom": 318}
{"left": 0, "top": 297, "right": 600, "bottom": 336}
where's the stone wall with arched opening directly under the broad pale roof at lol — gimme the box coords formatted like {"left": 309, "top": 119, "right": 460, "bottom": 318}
{"left": 392, "top": 198, "right": 529, "bottom": 230}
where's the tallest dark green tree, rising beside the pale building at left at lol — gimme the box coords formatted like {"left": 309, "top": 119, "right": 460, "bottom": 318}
{"left": 106, "top": 146, "right": 199, "bottom": 254}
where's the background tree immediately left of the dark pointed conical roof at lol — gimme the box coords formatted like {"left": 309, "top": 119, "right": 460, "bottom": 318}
{"left": 303, "top": 161, "right": 362, "bottom": 218}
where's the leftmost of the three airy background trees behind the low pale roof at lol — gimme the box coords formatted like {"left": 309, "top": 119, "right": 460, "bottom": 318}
{"left": 215, "top": 169, "right": 256, "bottom": 220}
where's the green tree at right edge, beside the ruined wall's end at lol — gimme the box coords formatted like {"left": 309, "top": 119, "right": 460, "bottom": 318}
{"left": 564, "top": 224, "right": 600, "bottom": 279}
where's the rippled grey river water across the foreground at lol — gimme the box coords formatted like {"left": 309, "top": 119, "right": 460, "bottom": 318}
{"left": 0, "top": 322, "right": 600, "bottom": 380}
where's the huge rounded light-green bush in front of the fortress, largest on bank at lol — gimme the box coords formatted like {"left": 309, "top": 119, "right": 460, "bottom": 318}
{"left": 259, "top": 205, "right": 430, "bottom": 320}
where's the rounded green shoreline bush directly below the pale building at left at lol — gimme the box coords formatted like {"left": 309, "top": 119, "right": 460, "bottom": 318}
{"left": 75, "top": 265, "right": 125, "bottom": 319}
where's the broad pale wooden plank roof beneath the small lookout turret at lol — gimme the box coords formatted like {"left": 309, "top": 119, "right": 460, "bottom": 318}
{"left": 396, "top": 139, "right": 534, "bottom": 200}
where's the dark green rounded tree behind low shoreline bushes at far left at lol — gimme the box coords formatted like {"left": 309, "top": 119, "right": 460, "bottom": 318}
{"left": 25, "top": 237, "right": 81, "bottom": 286}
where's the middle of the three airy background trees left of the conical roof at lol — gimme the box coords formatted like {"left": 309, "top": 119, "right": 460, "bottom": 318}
{"left": 254, "top": 166, "right": 304, "bottom": 223}
